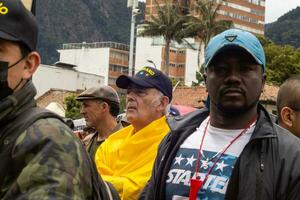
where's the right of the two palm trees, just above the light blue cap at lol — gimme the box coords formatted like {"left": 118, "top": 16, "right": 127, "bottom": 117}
{"left": 184, "top": 0, "right": 233, "bottom": 84}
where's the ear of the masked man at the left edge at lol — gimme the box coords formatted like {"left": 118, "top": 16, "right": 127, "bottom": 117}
{"left": 23, "top": 51, "right": 41, "bottom": 80}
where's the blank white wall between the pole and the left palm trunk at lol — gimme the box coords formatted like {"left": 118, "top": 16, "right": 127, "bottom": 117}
{"left": 135, "top": 37, "right": 162, "bottom": 72}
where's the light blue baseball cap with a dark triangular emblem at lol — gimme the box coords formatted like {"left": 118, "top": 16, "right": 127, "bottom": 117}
{"left": 204, "top": 29, "right": 266, "bottom": 71}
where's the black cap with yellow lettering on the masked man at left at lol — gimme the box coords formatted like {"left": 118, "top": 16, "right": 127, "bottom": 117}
{"left": 0, "top": 0, "right": 38, "bottom": 51}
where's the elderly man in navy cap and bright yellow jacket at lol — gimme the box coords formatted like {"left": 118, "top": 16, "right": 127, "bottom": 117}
{"left": 95, "top": 67, "right": 172, "bottom": 200}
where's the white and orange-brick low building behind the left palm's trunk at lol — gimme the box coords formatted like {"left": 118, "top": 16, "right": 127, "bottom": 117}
{"left": 135, "top": 34, "right": 198, "bottom": 85}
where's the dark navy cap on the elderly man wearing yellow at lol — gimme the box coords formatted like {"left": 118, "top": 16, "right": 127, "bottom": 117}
{"left": 116, "top": 67, "right": 172, "bottom": 102}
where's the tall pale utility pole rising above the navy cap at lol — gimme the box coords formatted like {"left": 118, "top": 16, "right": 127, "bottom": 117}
{"left": 127, "top": 0, "right": 141, "bottom": 76}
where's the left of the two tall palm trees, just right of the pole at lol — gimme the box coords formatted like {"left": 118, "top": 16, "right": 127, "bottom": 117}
{"left": 139, "top": 0, "right": 186, "bottom": 75}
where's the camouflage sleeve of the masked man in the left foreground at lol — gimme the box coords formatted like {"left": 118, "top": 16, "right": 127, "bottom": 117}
{"left": 6, "top": 118, "right": 92, "bottom": 200}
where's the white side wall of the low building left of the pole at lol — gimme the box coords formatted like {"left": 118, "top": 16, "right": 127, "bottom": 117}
{"left": 58, "top": 48, "right": 109, "bottom": 85}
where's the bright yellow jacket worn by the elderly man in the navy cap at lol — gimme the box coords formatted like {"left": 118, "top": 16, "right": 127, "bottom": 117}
{"left": 95, "top": 117, "right": 170, "bottom": 200}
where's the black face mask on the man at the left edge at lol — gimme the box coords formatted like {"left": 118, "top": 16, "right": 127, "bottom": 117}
{"left": 0, "top": 57, "right": 24, "bottom": 101}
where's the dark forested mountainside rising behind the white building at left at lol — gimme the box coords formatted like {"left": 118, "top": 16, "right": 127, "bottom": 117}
{"left": 36, "top": 0, "right": 144, "bottom": 64}
